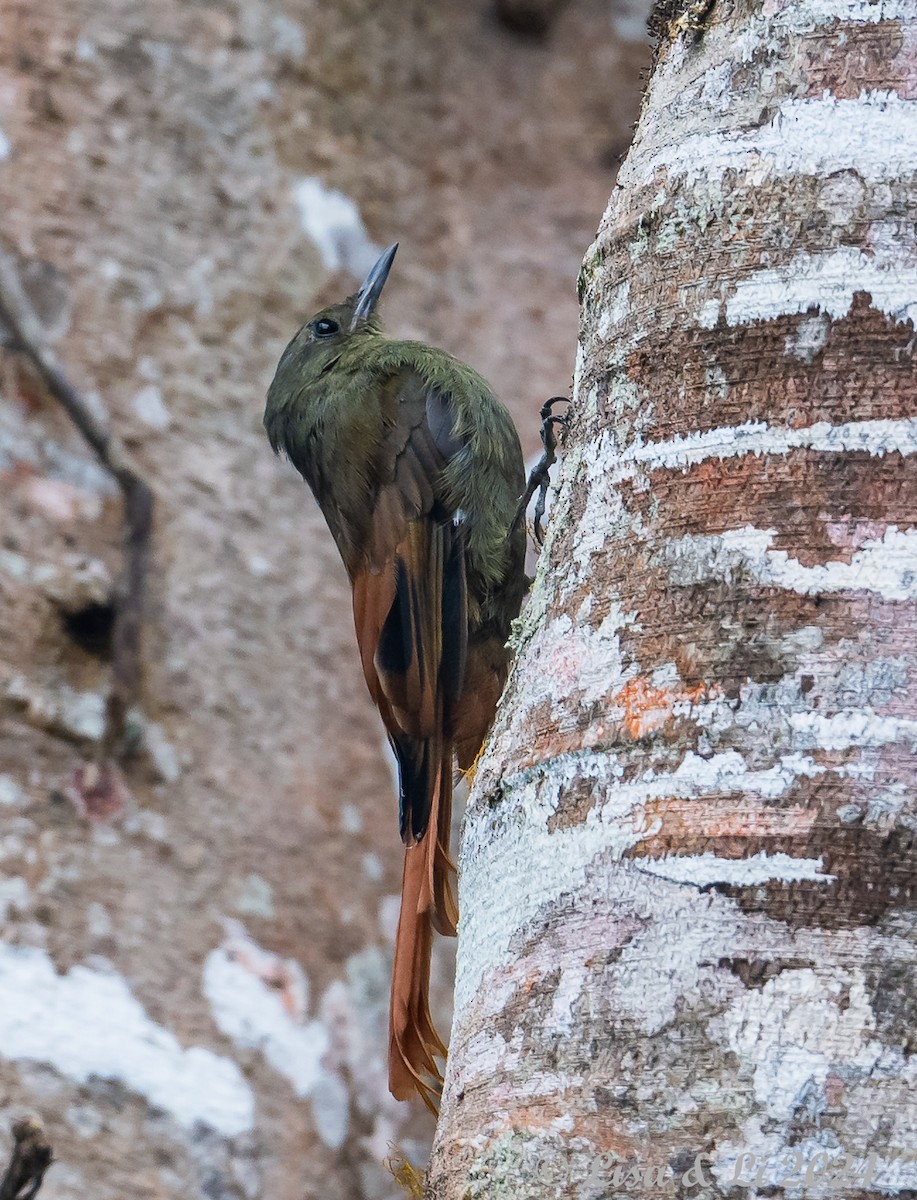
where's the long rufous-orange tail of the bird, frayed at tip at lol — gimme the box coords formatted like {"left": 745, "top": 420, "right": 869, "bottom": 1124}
{"left": 389, "top": 748, "right": 459, "bottom": 1112}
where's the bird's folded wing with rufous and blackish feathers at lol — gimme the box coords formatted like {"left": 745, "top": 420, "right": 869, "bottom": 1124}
{"left": 352, "top": 368, "right": 468, "bottom": 844}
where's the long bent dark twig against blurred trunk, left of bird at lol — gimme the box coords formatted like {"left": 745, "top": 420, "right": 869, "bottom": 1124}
{"left": 0, "top": 246, "right": 154, "bottom": 758}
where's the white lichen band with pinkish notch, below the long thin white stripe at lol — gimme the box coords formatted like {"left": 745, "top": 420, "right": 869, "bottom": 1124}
{"left": 661, "top": 526, "right": 917, "bottom": 601}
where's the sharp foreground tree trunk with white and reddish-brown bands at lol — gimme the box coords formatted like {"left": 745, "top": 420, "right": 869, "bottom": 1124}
{"left": 430, "top": 0, "right": 917, "bottom": 1200}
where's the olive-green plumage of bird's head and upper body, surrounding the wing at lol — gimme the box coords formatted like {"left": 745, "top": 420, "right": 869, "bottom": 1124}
{"left": 264, "top": 304, "right": 525, "bottom": 609}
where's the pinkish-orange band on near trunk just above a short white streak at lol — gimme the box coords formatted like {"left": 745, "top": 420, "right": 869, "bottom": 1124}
{"left": 631, "top": 796, "right": 819, "bottom": 857}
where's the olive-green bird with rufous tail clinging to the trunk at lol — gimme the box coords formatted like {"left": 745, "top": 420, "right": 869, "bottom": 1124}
{"left": 264, "top": 242, "right": 528, "bottom": 1111}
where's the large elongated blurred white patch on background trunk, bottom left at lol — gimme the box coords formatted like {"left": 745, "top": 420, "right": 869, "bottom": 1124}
{"left": 0, "top": 943, "right": 254, "bottom": 1136}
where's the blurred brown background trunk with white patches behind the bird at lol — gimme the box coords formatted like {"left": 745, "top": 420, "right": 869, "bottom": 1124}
{"left": 0, "top": 0, "right": 648, "bottom": 1200}
